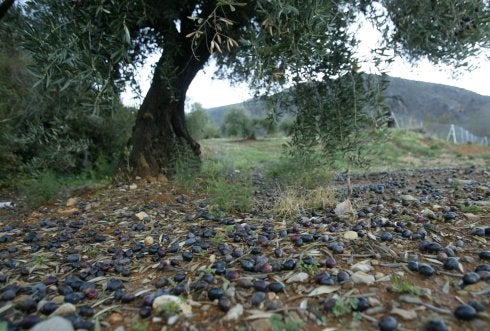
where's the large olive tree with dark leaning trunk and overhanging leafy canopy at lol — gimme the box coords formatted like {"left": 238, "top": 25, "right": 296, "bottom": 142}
{"left": 17, "top": 0, "right": 490, "bottom": 176}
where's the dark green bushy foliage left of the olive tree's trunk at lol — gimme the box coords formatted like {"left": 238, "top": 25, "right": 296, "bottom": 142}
{"left": 0, "top": 10, "right": 134, "bottom": 184}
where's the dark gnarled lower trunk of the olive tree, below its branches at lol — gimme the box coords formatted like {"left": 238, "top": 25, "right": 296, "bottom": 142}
{"left": 126, "top": 48, "right": 209, "bottom": 178}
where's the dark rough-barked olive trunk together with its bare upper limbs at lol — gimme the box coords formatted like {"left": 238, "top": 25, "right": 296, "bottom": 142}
{"left": 123, "top": 0, "right": 249, "bottom": 177}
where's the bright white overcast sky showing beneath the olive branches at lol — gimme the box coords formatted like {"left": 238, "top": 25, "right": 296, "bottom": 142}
{"left": 123, "top": 21, "right": 490, "bottom": 108}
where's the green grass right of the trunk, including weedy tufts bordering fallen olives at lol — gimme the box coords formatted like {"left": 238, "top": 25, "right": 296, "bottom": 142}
{"left": 193, "top": 129, "right": 490, "bottom": 217}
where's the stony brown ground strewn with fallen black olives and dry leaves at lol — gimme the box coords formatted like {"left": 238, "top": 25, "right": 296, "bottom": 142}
{"left": 0, "top": 168, "right": 490, "bottom": 331}
